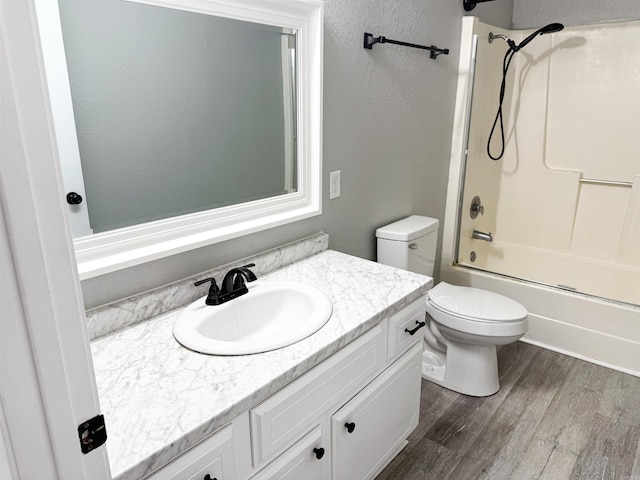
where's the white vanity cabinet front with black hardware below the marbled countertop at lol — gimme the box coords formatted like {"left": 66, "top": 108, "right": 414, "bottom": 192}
{"left": 144, "top": 297, "right": 426, "bottom": 480}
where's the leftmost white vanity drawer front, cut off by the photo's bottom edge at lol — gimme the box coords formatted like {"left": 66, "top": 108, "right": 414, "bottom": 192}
{"left": 147, "top": 424, "right": 236, "bottom": 480}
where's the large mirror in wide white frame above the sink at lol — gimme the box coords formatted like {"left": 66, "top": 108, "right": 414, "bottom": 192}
{"left": 37, "top": 0, "right": 322, "bottom": 279}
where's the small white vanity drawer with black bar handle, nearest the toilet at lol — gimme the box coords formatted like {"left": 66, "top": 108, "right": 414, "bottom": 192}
{"left": 387, "top": 297, "right": 427, "bottom": 360}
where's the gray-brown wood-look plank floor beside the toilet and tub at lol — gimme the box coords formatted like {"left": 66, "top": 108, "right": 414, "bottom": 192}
{"left": 377, "top": 342, "right": 640, "bottom": 480}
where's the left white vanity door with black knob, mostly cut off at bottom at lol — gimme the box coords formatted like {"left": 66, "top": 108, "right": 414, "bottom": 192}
{"left": 251, "top": 426, "right": 329, "bottom": 480}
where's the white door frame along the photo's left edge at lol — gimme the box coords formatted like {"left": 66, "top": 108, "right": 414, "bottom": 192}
{"left": 0, "top": 0, "right": 111, "bottom": 480}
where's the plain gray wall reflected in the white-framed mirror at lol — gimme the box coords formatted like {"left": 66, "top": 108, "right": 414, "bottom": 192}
{"left": 60, "top": 0, "right": 284, "bottom": 233}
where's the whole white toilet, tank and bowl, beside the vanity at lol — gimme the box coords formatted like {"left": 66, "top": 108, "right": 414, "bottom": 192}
{"left": 376, "top": 215, "right": 528, "bottom": 397}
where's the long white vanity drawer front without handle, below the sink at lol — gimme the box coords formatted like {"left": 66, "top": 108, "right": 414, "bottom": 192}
{"left": 250, "top": 323, "right": 386, "bottom": 467}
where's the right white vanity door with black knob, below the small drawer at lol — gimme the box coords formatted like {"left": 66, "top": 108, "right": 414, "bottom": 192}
{"left": 331, "top": 344, "right": 422, "bottom": 480}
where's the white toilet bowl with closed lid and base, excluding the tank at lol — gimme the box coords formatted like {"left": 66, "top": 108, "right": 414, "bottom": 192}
{"left": 422, "top": 282, "right": 528, "bottom": 397}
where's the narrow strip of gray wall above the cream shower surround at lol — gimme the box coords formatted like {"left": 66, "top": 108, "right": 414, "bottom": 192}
{"left": 513, "top": 0, "right": 640, "bottom": 29}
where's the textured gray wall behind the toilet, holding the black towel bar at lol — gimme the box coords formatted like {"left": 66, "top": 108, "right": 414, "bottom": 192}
{"left": 82, "top": 0, "right": 513, "bottom": 308}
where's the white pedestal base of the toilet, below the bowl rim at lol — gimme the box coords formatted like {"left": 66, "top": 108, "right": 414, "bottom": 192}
{"left": 422, "top": 342, "right": 500, "bottom": 397}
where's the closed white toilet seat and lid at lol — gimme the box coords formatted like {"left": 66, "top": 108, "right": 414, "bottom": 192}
{"left": 427, "top": 282, "right": 528, "bottom": 337}
